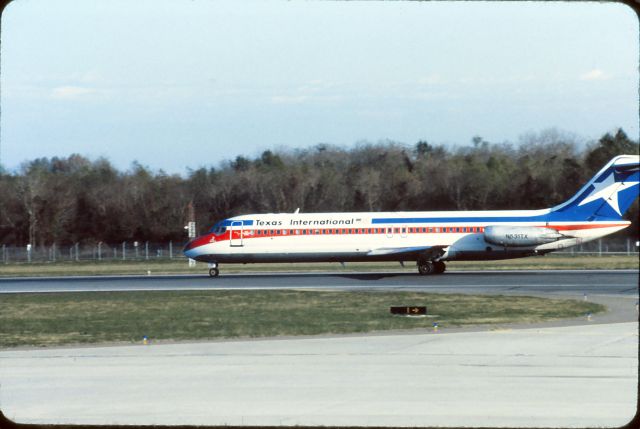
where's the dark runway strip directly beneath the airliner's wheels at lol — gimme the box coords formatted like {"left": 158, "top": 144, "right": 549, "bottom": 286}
{"left": 0, "top": 270, "right": 638, "bottom": 297}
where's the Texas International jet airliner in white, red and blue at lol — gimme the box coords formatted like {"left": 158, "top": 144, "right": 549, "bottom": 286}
{"left": 184, "top": 155, "right": 640, "bottom": 277}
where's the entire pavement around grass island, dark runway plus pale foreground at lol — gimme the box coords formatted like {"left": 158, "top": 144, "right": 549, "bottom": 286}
{"left": 0, "top": 270, "right": 638, "bottom": 427}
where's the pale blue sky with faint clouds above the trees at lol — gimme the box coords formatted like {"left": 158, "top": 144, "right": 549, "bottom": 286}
{"left": 0, "top": 0, "right": 639, "bottom": 173}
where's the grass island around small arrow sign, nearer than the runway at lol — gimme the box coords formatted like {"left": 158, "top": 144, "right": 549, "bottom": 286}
{"left": 0, "top": 290, "right": 605, "bottom": 348}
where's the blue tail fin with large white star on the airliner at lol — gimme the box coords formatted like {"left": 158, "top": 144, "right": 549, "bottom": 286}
{"left": 549, "top": 155, "right": 640, "bottom": 221}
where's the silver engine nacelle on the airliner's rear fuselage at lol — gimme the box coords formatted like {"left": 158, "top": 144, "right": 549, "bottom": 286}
{"left": 484, "top": 225, "right": 566, "bottom": 247}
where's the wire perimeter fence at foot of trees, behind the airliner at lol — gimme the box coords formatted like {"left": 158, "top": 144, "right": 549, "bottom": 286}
{"left": 0, "top": 238, "right": 639, "bottom": 264}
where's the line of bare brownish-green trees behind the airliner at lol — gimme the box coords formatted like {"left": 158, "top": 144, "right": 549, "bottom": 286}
{"left": 0, "top": 129, "right": 639, "bottom": 246}
